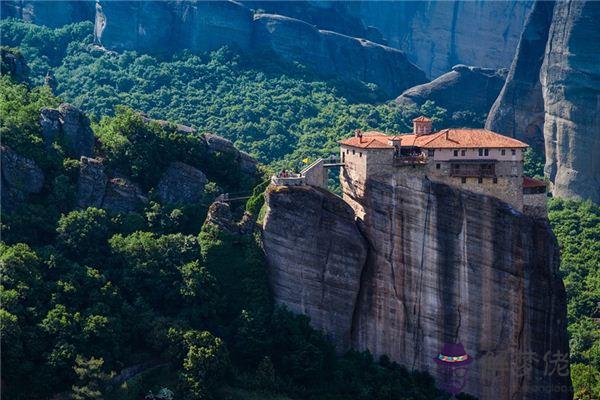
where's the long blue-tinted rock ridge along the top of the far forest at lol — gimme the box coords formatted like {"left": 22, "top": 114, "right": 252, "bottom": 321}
{"left": 89, "top": 1, "right": 426, "bottom": 96}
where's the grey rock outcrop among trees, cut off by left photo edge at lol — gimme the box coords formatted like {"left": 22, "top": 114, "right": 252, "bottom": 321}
{"left": 0, "top": 146, "right": 44, "bottom": 212}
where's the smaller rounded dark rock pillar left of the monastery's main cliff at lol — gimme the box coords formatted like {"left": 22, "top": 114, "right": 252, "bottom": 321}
{"left": 263, "top": 186, "right": 367, "bottom": 349}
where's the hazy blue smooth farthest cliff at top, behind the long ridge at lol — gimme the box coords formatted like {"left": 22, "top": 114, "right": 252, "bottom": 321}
{"left": 243, "top": 1, "right": 532, "bottom": 78}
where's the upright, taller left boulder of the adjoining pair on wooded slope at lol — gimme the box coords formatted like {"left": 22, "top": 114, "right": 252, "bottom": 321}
{"left": 77, "top": 157, "right": 108, "bottom": 208}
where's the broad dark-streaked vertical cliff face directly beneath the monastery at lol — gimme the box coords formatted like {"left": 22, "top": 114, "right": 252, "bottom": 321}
{"left": 343, "top": 173, "right": 569, "bottom": 399}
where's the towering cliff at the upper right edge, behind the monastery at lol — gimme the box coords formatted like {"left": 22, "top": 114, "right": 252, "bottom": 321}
{"left": 486, "top": 1, "right": 600, "bottom": 202}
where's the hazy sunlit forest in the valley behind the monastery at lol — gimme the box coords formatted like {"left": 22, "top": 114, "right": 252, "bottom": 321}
{"left": 0, "top": 20, "right": 484, "bottom": 170}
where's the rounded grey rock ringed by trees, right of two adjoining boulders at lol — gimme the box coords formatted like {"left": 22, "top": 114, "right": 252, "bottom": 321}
{"left": 157, "top": 162, "right": 207, "bottom": 204}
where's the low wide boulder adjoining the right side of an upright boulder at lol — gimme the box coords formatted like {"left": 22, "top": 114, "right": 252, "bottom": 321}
{"left": 102, "top": 177, "right": 148, "bottom": 213}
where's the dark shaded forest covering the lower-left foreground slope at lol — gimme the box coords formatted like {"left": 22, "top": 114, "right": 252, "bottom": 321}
{"left": 0, "top": 72, "right": 439, "bottom": 399}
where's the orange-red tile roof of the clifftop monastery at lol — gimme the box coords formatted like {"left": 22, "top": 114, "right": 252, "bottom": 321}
{"left": 340, "top": 129, "right": 528, "bottom": 149}
